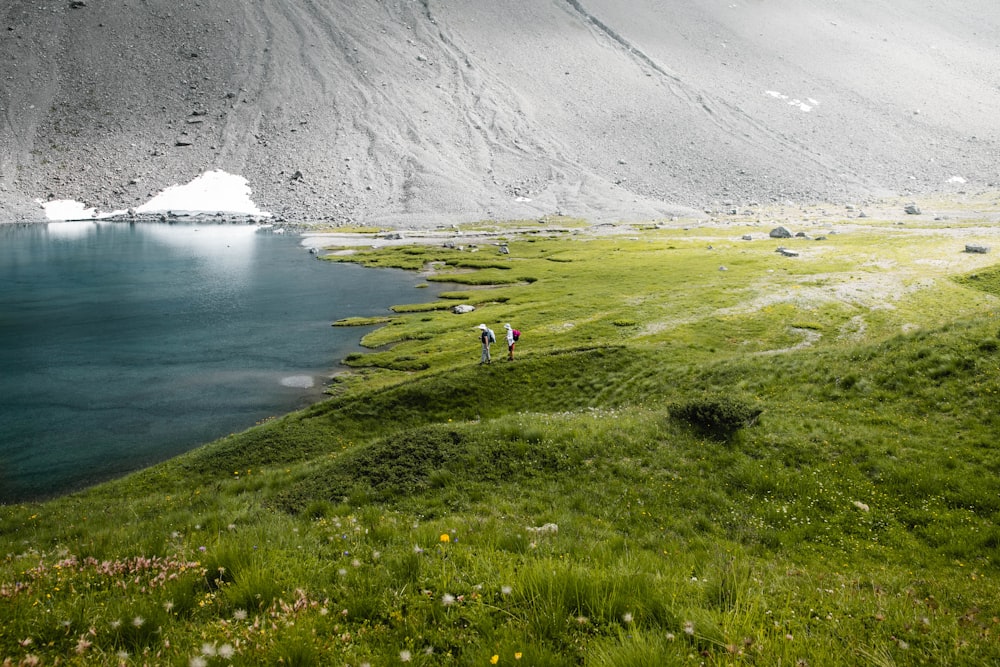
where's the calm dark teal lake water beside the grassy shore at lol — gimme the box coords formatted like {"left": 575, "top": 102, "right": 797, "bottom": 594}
{"left": 0, "top": 222, "right": 440, "bottom": 502}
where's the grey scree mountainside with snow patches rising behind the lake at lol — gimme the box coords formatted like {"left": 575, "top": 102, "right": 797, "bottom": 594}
{"left": 0, "top": 0, "right": 1000, "bottom": 227}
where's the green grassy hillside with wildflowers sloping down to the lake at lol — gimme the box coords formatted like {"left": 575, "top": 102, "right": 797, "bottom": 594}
{"left": 0, "top": 206, "right": 1000, "bottom": 665}
